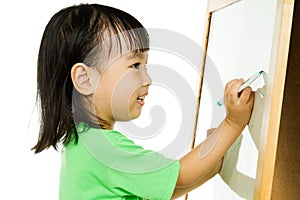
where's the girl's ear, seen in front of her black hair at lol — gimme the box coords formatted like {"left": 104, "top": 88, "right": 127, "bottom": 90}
{"left": 71, "top": 63, "right": 96, "bottom": 95}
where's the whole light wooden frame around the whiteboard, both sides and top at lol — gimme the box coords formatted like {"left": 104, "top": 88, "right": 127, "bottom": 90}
{"left": 189, "top": 0, "right": 294, "bottom": 200}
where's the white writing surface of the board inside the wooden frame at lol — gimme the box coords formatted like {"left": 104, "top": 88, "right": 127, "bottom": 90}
{"left": 189, "top": 0, "right": 276, "bottom": 200}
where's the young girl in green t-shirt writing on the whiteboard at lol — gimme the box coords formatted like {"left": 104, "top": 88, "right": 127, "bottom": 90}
{"left": 33, "top": 4, "right": 253, "bottom": 200}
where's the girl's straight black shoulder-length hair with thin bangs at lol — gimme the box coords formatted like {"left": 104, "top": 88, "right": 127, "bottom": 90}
{"left": 32, "top": 4, "right": 149, "bottom": 153}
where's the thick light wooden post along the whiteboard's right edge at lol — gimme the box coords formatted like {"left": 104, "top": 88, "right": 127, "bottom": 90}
{"left": 254, "top": 0, "right": 294, "bottom": 200}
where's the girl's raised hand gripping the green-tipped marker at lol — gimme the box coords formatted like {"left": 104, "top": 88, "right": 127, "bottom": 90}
{"left": 224, "top": 79, "right": 254, "bottom": 128}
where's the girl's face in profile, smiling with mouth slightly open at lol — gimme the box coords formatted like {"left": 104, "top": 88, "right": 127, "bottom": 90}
{"left": 94, "top": 52, "right": 151, "bottom": 128}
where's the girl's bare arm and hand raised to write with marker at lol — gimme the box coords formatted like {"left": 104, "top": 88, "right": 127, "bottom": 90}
{"left": 172, "top": 80, "right": 254, "bottom": 198}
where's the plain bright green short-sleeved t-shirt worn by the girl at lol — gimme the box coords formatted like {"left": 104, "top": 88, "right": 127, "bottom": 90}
{"left": 59, "top": 123, "right": 180, "bottom": 200}
